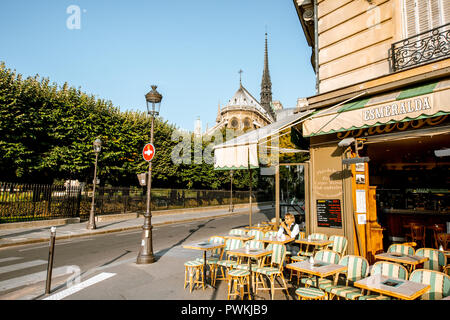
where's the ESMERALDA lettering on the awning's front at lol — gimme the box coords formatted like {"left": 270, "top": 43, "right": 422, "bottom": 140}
{"left": 363, "top": 97, "right": 431, "bottom": 121}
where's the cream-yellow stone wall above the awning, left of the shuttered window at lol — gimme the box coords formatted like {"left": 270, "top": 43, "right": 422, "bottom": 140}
{"left": 318, "top": 0, "right": 402, "bottom": 93}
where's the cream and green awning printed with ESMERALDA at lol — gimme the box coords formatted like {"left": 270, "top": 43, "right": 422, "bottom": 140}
{"left": 303, "top": 79, "right": 450, "bottom": 137}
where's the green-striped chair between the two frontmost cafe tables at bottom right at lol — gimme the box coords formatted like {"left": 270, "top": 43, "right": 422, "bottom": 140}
{"left": 326, "top": 255, "right": 369, "bottom": 300}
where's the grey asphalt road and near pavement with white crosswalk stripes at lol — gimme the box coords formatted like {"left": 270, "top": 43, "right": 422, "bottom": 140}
{"left": 0, "top": 212, "right": 292, "bottom": 300}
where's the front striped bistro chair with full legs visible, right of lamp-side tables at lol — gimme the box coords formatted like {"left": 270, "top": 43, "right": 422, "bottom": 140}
{"left": 255, "top": 244, "right": 288, "bottom": 300}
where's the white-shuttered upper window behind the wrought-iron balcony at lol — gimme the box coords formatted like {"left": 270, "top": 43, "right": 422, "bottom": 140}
{"left": 403, "top": 0, "right": 450, "bottom": 38}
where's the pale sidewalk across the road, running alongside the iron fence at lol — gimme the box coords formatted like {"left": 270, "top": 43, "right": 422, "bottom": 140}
{"left": 0, "top": 204, "right": 273, "bottom": 248}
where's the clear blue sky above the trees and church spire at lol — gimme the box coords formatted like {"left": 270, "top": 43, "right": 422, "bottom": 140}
{"left": 0, "top": 0, "right": 315, "bottom": 130}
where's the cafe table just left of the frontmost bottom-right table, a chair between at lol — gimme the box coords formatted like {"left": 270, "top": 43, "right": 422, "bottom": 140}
{"left": 286, "top": 260, "right": 347, "bottom": 288}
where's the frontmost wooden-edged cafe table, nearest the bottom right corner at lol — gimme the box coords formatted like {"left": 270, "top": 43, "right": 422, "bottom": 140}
{"left": 353, "top": 274, "right": 431, "bottom": 300}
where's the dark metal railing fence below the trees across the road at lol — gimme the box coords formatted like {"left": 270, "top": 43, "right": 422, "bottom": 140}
{"left": 0, "top": 182, "right": 273, "bottom": 223}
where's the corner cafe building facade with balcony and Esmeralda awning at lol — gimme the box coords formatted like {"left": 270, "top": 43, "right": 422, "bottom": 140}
{"left": 293, "top": 0, "right": 450, "bottom": 262}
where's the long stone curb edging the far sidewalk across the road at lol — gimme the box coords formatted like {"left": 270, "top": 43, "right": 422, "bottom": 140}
{"left": 0, "top": 208, "right": 272, "bottom": 249}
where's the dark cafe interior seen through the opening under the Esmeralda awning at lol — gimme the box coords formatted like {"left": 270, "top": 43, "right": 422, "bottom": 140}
{"left": 364, "top": 134, "right": 450, "bottom": 249}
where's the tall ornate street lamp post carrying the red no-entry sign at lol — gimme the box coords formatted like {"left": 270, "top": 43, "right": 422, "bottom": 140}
{"left": 136, "top": 86, "right": 162, "bottom": 264}
